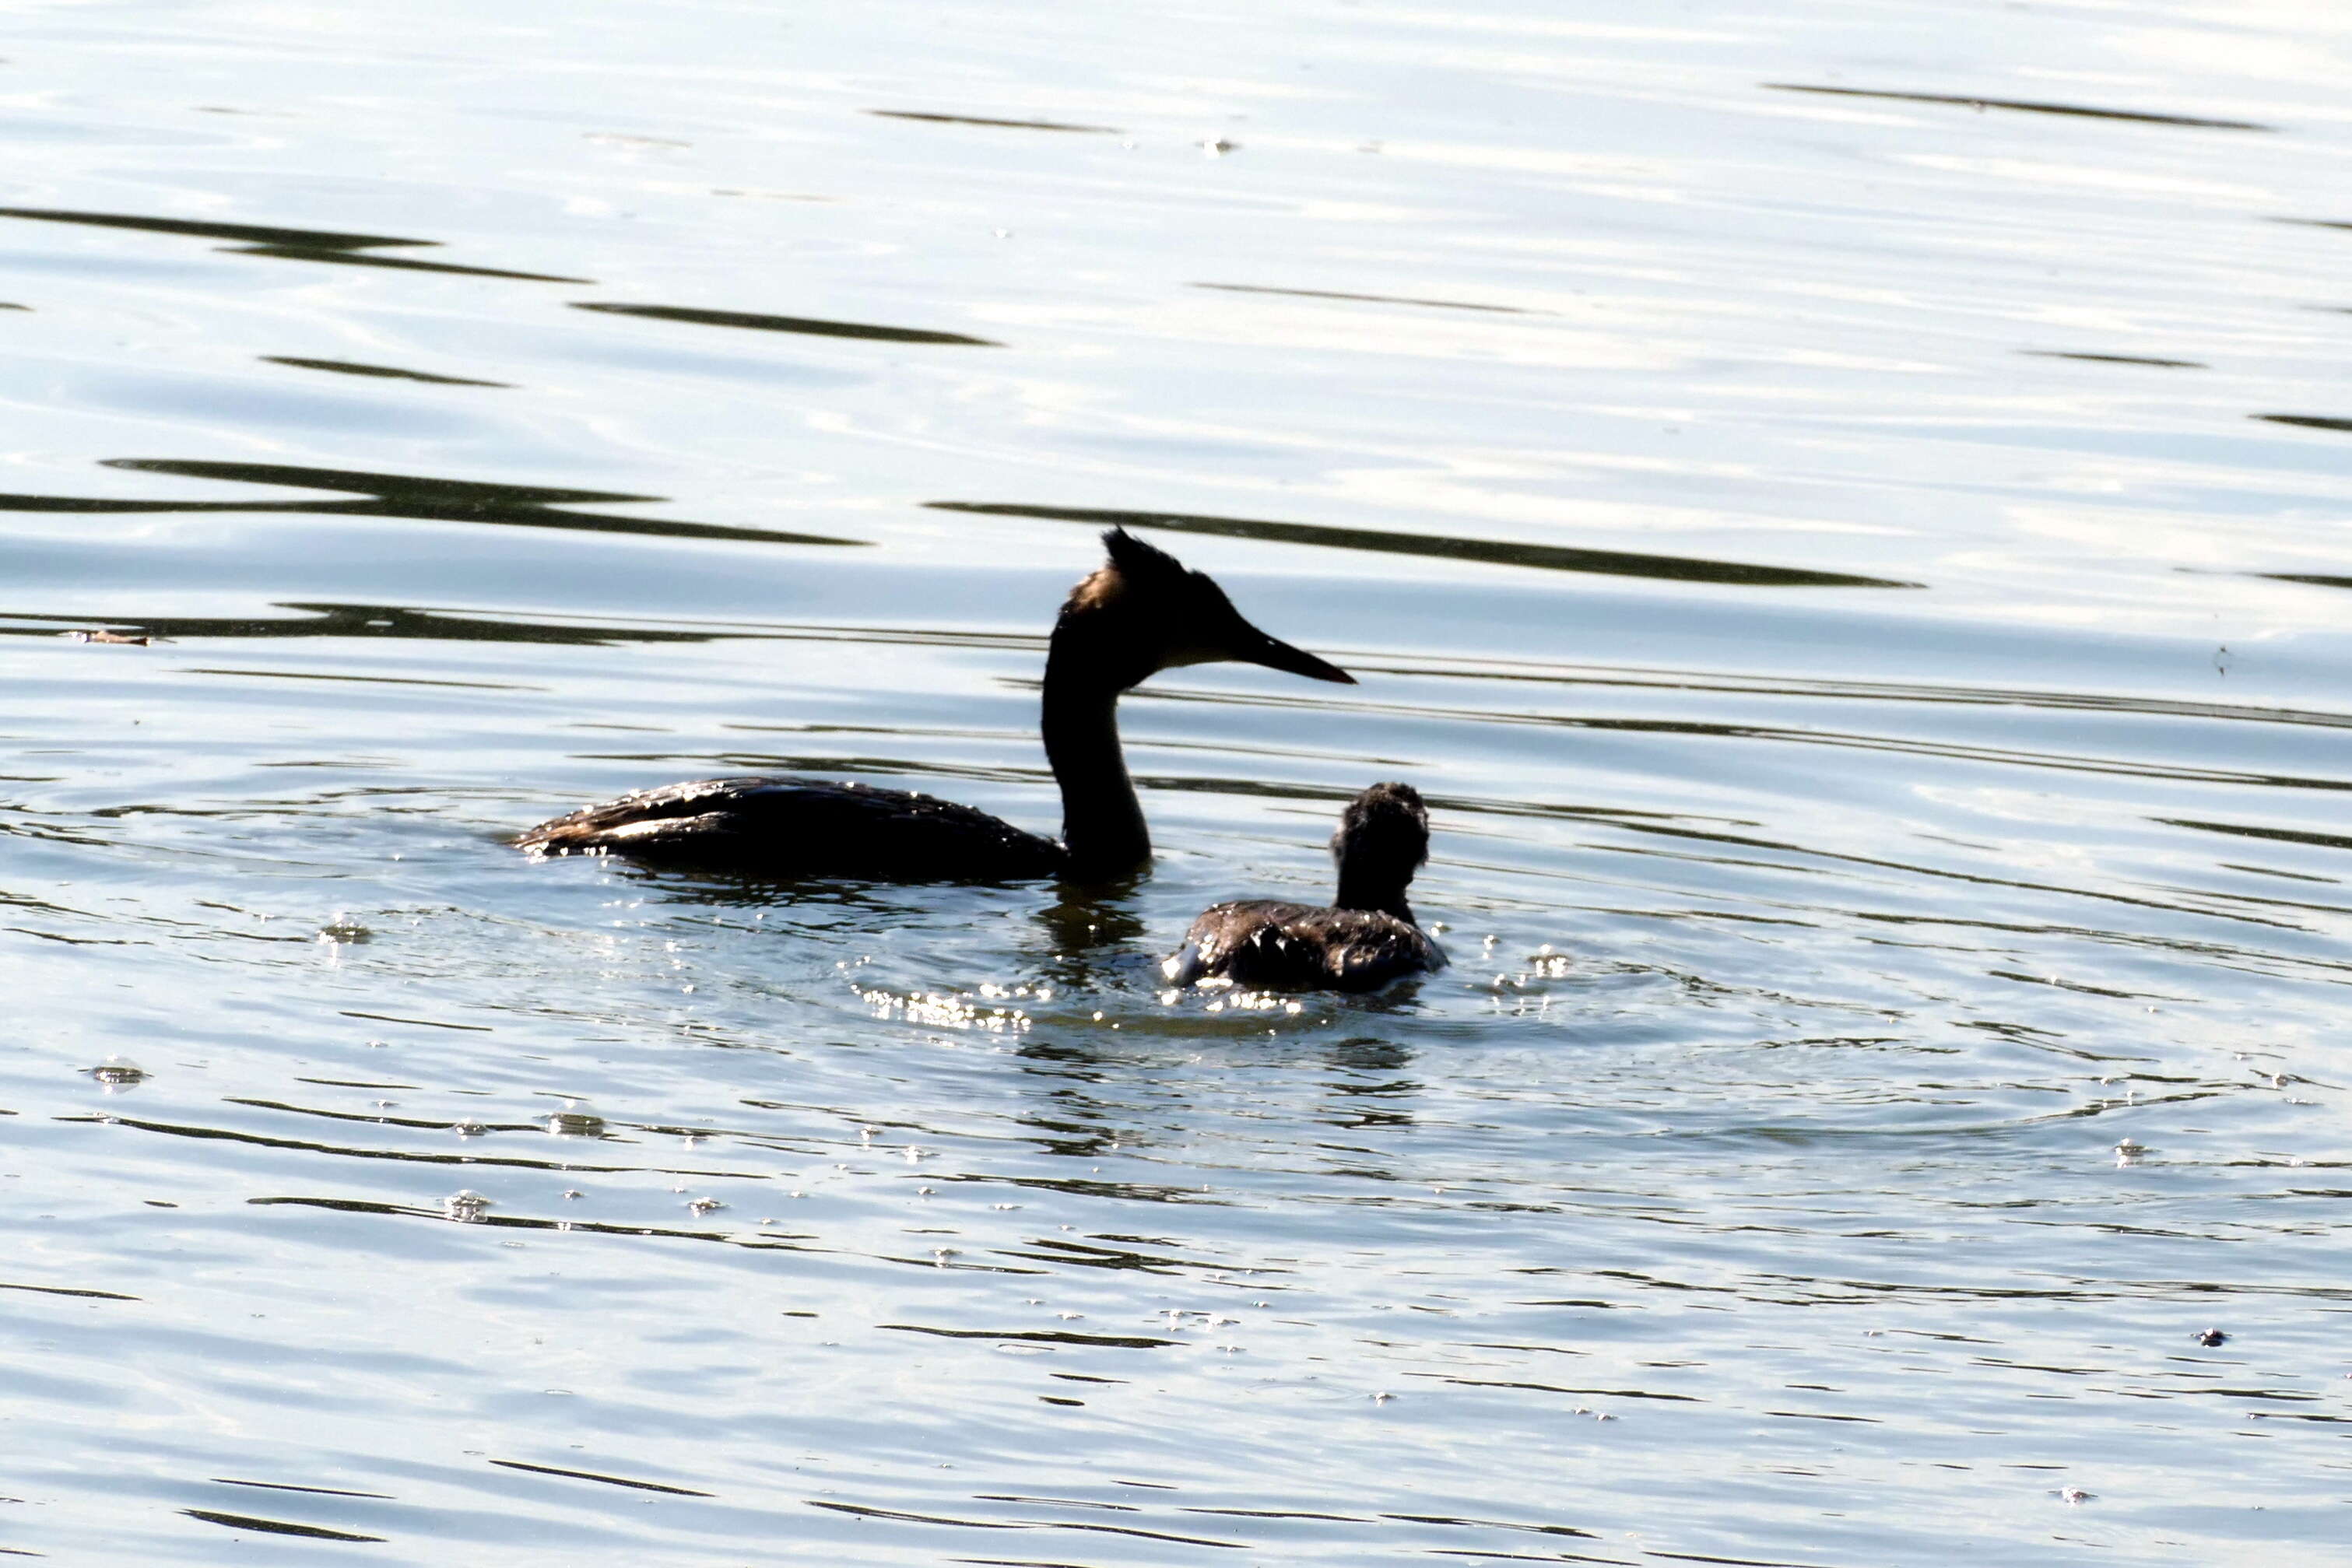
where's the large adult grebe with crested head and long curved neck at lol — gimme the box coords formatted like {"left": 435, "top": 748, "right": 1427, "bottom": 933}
{"left": 515, "top": 529, "right": 1355, "bottom": 882}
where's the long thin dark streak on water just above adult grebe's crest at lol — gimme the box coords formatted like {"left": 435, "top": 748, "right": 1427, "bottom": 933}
{"left": 925, "top": 500, "right": 1922, "bottom": 588}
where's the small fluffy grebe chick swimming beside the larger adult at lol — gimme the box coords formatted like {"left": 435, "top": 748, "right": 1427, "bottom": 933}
{"left": 1160, "top": 783, "right": 1447, "bottom": 992}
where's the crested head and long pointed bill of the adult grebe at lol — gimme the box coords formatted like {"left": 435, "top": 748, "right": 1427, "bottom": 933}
{"left": 1054, "top": 529, "right": 1355, "bottom": 691}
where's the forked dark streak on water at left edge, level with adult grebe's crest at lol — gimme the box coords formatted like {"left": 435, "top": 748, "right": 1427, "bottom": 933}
{"left": 0, "top": 458, "right": 868, "bottom": 545}
